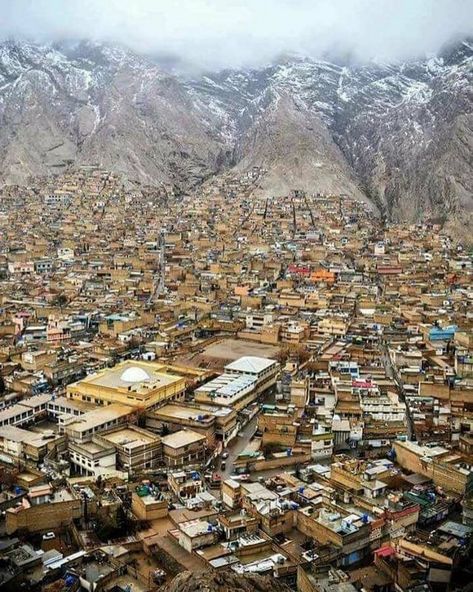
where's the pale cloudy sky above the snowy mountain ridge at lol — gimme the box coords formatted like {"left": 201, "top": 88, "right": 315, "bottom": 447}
{"left": 0, "top": 0, "right": 473, "bottom": 68}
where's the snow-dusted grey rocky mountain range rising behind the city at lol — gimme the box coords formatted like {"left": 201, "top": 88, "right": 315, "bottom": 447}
{"left": 0, "top": 41, "right": 473, "bottom": 220}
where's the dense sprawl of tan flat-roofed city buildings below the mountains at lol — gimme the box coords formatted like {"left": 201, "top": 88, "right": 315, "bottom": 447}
{"left": 0, "top": 166, "right": 473, "bottom": 592}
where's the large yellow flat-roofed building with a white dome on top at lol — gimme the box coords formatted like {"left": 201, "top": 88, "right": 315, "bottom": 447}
{"left": 66, "top": 360, "right": 186, "bottom": 409}
